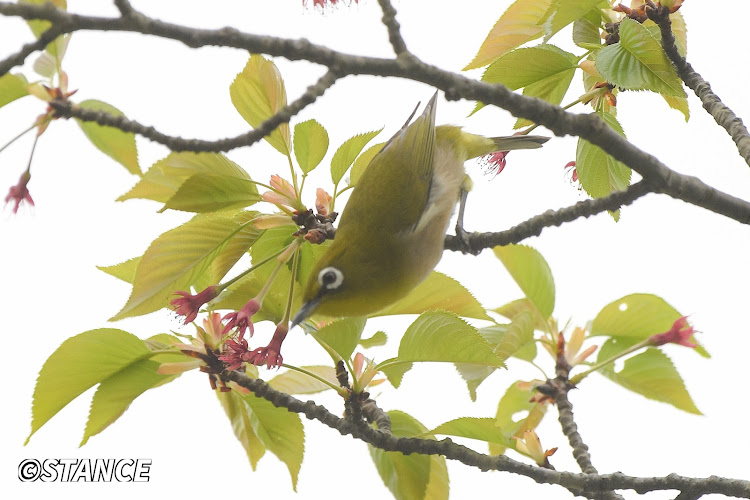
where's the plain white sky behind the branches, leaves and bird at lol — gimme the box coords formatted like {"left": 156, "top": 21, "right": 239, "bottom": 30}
{"left": 0, "top": 0, "right": 750, "bottom": 499}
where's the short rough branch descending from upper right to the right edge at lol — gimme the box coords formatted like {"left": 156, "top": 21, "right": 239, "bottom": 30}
{"left": 646, "top": 7, "right": 750, "bottom": 165}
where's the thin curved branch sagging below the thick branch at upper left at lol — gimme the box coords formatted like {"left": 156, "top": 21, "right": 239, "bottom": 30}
{"left": 49, "top": 71, "right": 339, "bottom": 153}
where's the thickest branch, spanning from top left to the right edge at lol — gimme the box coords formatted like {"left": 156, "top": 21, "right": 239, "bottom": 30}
{"left": 0, "top": 2, "right": 750, "bottom": 228}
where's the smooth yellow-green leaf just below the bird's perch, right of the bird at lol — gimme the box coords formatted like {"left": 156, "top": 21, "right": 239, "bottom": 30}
{"left": 492, "top": 244, "right": 556, "bottom": 318}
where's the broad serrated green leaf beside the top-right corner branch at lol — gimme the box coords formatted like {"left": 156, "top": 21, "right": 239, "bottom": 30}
{"left": 596, "top": 18, "right": 686, "bottom": 97}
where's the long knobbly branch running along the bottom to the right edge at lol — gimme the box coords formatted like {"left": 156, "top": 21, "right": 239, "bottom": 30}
{"left": 220, "top": 371, "right": 750, "bottom": 498}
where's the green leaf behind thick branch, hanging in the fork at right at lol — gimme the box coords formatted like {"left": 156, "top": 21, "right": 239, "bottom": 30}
{"left": 576, "top": 113, "right": 631, "bottom": 212}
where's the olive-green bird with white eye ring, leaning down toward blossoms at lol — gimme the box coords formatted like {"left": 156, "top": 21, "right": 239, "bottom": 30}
{"left": 292, "top": 93, "right": 548, "bottom": 326}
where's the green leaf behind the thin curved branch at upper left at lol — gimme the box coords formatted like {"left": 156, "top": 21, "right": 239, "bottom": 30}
{"left": 76, "top": 99, "right": 141, "bottom": 175}
